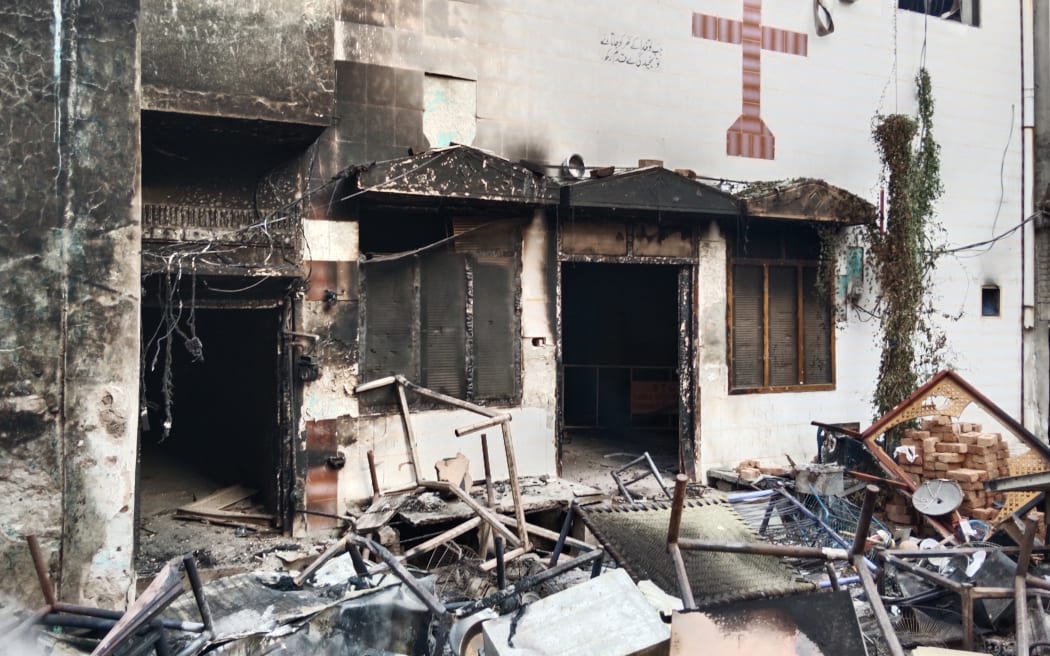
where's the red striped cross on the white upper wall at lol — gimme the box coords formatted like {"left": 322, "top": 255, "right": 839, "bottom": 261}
{"left": 693, "top": 0, "right": 809, "bottom": 160}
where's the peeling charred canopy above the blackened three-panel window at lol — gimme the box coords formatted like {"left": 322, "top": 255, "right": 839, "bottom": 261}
{"left": 345, "top": 145, "right": 558, "bottom": 206}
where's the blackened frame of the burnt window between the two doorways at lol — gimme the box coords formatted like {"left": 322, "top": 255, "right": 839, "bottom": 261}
{"left": 359, "top": 215, "right": 523, "bottom": 411}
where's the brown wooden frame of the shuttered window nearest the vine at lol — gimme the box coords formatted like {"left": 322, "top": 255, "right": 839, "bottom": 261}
{"left": 726, "top": 225, "right": 837, "bottom": 395}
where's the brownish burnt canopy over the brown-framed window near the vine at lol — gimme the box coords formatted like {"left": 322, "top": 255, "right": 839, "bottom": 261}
{"left": 736, "top": 178, "right": 878, "bottom": 226}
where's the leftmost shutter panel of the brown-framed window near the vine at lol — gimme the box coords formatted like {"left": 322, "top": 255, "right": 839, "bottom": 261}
{"left": 732, "top": 264, "right": 764, "bottom": 387}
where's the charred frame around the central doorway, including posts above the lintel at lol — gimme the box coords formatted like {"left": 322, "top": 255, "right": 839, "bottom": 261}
{"left": 554, "top": 217, "right": 698, "bottom": 481}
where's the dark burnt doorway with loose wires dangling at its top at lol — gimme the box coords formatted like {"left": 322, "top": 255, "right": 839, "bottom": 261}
{"left": 139, "top": 276, "right": 291, "bottom": 541}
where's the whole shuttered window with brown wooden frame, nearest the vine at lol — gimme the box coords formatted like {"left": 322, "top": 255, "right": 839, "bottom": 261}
{"left": 729, "top": 225, "right": 835, "bottom": 392}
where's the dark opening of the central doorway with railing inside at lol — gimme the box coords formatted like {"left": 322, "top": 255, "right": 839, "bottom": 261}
{"left": 561, "top": 262, "right": 683, "bottom": 466}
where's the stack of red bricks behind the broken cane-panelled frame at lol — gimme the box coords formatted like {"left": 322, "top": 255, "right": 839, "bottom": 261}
{"left": 886, "top": 416, "right": 1010, "bottom": 524}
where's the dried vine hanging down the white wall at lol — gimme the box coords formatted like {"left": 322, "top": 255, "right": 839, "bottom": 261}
{"left": 867, "top": 68, "right": 944, "bottom": 416}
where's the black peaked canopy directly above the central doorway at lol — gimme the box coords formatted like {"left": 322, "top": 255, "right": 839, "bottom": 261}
{"left": 562, "top": 166, "right": 740, "bottom": 216}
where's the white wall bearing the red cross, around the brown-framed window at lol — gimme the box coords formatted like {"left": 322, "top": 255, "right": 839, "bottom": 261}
{"left": 337, "top": 0, "right": 1024, "bottom": 476}
